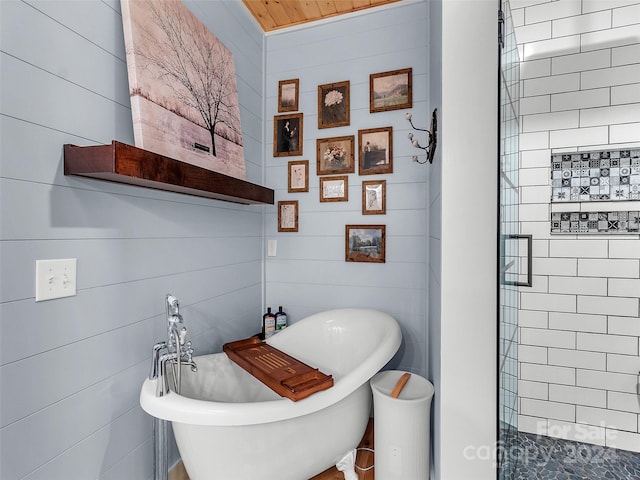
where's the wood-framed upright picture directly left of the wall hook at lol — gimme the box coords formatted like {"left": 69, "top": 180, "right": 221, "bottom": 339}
{"left": 358, "top": 127, "right": 393, "bottom": 175}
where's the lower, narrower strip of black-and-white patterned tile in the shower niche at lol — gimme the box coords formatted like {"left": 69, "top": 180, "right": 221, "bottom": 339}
{"left": 551, "top": 210, "right": 640, "bottom": 234}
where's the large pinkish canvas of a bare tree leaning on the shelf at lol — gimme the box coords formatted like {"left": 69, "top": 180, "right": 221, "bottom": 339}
{"left": 121, "top": 0, "right": 246, "bottom": 180}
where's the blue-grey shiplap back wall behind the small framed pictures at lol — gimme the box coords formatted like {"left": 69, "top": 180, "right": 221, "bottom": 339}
{"left": 265, "top": 1, "right": 429, "bottom": 375}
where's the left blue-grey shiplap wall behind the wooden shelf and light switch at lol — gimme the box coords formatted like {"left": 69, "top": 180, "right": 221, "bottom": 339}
{"left": 0, "top": 0, "right": 264, "bottom": 480}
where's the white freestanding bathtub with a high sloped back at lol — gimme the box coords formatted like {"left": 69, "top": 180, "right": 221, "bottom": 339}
{"left": 140, "top": 309, "right": 402, "bottom": 480}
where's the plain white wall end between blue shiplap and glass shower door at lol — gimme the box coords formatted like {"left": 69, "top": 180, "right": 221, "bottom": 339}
{"left": 438, "top": 0, "right": 498, "bottom": 480}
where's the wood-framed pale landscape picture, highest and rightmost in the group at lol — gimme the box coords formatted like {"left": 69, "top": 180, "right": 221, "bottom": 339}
{"left": 369, "top": 68, "right": 413, "bottom": 113}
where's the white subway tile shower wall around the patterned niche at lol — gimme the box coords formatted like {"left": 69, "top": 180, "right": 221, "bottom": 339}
{"left": 511, "top": 0, "right": 640, "bottom": 452}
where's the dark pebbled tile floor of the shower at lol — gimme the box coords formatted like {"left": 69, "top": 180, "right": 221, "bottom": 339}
{"left": 501, "top": 432, "right": 640, "bottom": 480}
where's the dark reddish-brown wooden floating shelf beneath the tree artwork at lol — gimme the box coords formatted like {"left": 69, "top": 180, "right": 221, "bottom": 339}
{"left": 64, "top": 140, "right": 273, "bottom": 205}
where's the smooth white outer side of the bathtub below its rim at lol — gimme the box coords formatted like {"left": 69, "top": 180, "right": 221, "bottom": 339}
{"left": 173, "top": 385, "right": 371, "bottom": 480}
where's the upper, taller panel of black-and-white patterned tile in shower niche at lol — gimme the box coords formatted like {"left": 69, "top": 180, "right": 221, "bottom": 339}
{"left": 551, "top": 149, "right": 640, "bottom": 202}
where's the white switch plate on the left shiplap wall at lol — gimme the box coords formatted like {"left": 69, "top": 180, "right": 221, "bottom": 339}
{"left": 36, "top": 258, "right": 77, "bottom": 302}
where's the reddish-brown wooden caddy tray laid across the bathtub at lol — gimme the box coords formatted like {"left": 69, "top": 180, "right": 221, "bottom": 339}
{"left": 222, "top": 337, "right": 333, "bottom": 402}
